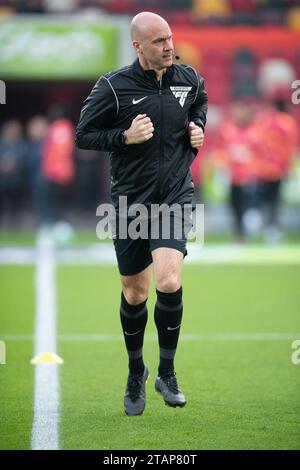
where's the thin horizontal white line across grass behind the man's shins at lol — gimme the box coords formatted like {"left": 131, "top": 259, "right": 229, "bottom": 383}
{"left": 0, "top": 332, "right": 300, "bottom": 343}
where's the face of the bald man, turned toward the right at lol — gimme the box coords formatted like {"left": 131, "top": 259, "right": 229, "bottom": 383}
{"left": 136, "top": 24, "right": 174, "bottom": 70}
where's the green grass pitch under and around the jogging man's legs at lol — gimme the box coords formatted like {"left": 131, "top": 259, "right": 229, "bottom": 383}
{"left": 0, "top": 265, "right": 300, "bottom": 450}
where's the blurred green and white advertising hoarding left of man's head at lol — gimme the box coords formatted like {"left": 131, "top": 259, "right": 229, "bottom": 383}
{"left": 0, "top": 17, "right": 119, "bottom": 80}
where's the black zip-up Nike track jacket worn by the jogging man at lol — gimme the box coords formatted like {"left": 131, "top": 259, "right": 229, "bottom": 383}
{"left": 76, "top": 59, "right": 207, "bottom": 208}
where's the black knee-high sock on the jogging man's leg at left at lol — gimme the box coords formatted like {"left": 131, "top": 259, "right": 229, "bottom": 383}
{"left": 120, "top": 292, "right": 148, "bottom": 374}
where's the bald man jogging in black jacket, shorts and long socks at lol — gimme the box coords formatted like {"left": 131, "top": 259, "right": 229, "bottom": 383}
{"left": 76, "top": 12, "right": 207, "bottom": 416}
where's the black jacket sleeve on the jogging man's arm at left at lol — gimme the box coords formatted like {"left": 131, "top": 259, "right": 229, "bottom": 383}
{"left": 75, "top": 76, "right": 125, "bottom": 152}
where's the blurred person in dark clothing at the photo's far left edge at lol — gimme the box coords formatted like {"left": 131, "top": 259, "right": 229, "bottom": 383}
{"left": 0, "top": 120, "right": 26, "bottom": 229}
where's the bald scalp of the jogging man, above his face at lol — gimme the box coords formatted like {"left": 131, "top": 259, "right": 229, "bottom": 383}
{"left": 130, "top": 11, "right": 169, "bottom": 41}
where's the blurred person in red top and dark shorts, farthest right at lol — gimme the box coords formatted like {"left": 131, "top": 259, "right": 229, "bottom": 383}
{"left": 256, "top": 97, "right": 298, "bottom": 242}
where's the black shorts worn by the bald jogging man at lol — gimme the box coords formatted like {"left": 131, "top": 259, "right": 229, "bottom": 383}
{"left": 113, "top": 212, "right": 187, "bottom": 276}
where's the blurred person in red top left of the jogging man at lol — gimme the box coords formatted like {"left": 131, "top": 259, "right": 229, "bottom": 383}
{"left": 40, "top": 107, "right": 74, "bottom": 225}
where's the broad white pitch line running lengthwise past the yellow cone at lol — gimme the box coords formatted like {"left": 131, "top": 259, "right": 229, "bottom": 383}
{"left": 31, "top": 240, "right": 60, "bottom": 450}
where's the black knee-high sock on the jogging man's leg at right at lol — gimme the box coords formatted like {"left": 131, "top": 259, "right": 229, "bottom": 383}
{"left": 154, "top": 287, "right": 183, "bottom": 375}
